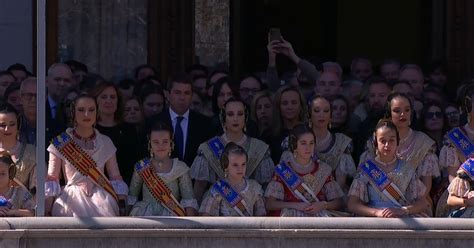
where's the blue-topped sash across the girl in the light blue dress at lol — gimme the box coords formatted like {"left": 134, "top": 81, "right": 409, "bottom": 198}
{"left": 361, "top": 160, "right": 407, "bottom": 207}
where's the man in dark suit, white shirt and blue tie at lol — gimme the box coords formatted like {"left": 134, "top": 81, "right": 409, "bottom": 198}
{"left": 150, "top": 75, "right": 212, "bottom": 166}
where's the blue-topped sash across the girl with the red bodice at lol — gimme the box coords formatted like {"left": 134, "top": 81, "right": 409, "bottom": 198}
{"left": 275, "top": 161, "right": 318, "bottom": 203}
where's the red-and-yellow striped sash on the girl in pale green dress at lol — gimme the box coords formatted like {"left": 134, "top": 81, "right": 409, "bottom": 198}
{"left": 135, "top": 159, "right": 186, "bottom": 216}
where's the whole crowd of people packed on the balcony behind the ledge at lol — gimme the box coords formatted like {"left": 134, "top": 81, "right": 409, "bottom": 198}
{"left": 0, "top": 38, "right": 474, "bottom": 218}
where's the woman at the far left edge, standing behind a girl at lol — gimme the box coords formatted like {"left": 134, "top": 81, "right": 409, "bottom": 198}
{"left": 0, "top": 103, "right": 36, "bottom": 195}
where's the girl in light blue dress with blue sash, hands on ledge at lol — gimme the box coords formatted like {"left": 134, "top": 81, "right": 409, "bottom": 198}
{"left": 348, "top": 120, "right": 429, "bottom": 218}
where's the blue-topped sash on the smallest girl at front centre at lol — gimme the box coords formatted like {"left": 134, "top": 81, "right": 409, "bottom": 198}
{"left": 212, "top": 180, "right": 251, "bottom": 217}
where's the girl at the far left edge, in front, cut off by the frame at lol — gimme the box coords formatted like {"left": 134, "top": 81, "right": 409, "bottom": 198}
{"left": 0, "top": 151, "right": 35, "bottom": 217}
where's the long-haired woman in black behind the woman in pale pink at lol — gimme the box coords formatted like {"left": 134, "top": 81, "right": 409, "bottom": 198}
{"left": 91, "top": 82, "right": 142, "bottom": 184}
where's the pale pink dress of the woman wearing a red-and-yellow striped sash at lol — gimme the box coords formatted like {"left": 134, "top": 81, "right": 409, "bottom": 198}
{"left": 45, "top": 128, "right": 128, "bottom": 217}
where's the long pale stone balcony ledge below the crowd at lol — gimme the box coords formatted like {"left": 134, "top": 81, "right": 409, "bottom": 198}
{"left": 0, "top": 217, "right": 474, "bottom": 248}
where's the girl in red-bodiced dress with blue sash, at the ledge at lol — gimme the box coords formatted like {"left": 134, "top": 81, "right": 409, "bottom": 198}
{"left": 265, "top": 124, "right": 343, "bottom": 217}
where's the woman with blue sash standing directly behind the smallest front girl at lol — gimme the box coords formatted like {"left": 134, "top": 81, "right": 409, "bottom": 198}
{"left": 191, "top": 98, "right": 274, "bottom": 201}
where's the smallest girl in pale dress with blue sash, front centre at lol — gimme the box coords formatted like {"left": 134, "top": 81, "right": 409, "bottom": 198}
{"left": 199, "top": 142, "right": 266, "bottom": 216}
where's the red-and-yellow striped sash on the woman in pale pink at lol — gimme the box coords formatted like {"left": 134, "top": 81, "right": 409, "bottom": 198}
{"left": 52, "top": 132, "right": 118, "bottom": 201}
